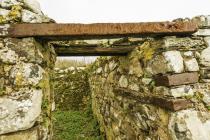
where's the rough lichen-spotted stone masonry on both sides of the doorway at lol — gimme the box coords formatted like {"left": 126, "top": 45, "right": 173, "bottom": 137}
{"left": 0, "top": 0, "right": 210, "bottom": 140}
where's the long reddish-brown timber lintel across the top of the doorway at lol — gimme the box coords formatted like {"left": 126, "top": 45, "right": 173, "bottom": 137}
{"left": 0, "top": 22, "right": 198, "bottom": 40}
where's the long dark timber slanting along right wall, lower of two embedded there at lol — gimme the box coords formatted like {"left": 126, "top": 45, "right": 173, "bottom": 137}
{"left": 114, "top": 88, "right": 193, "bottom": 111}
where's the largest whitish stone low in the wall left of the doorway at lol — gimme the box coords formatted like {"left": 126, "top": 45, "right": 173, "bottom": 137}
{"left": 0, "top": 88, "right": 42, "bottom": 134}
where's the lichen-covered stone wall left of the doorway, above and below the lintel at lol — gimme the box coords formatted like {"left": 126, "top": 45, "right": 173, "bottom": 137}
{"left": 0, "top": 0, "right": 55, "bottom": 140}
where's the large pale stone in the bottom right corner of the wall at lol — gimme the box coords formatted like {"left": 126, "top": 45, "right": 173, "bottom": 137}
{"left": 168, "top": 110, "right": 210, "bottom": 140}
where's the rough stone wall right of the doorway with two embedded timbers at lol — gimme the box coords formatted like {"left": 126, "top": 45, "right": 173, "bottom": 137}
{"left": 89, "top": 16, "right": 210, "bottom": 140}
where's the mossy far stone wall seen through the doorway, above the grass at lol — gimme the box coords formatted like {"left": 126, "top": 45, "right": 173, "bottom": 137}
{"left": 54, "top": 67, "right": 90, "bottom": 111}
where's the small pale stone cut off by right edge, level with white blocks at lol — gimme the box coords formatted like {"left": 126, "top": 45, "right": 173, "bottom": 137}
{"left": 200, "top": 47, "right": 210, "bottom": 67}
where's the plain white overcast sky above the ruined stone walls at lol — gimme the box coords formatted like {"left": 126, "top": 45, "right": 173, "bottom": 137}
{"left": 39, "top": 0, "right": 210, "bottom": 23}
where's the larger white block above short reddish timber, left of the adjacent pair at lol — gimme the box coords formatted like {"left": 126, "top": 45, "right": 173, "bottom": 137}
{"left": 163, "top": 51, "right": 184, "bottom": 73}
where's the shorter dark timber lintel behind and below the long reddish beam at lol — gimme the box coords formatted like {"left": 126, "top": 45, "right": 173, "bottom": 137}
{"left": 54, "top": 46, "right": 135, "bottom": 56}
